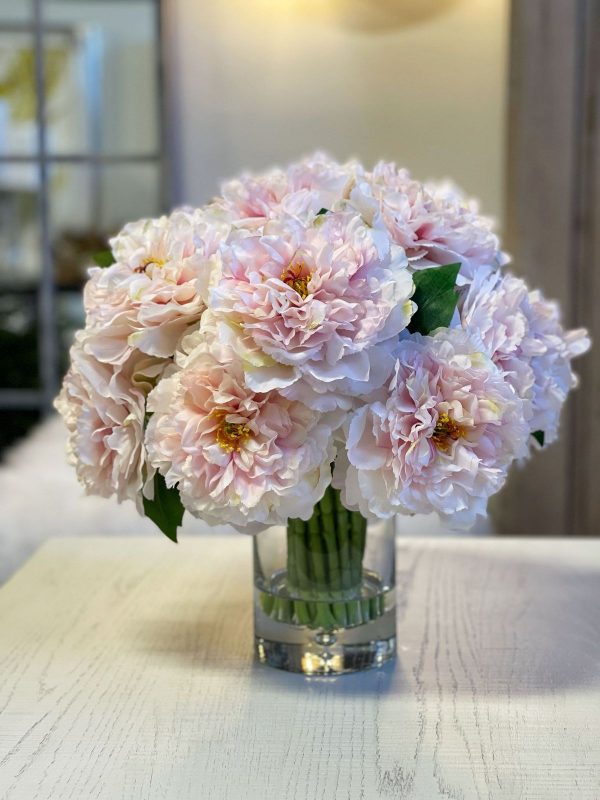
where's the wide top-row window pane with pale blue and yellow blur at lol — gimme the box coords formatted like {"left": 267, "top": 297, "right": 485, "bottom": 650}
{"left": 43, "top": 0, "right": 159, "bottom": 155}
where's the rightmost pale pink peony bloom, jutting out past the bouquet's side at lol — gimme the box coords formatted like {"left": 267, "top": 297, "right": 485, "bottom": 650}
{"left": 460, "top": 269, "right": 590, "bottom": 444}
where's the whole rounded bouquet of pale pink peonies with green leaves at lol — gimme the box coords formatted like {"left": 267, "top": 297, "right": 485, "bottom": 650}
{"left": 56, "top": 154, "right": 589, "bottom": 539}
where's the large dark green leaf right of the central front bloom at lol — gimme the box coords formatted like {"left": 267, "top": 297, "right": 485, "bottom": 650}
{"left": 408, "top": 264, "right": 460, "bottom": 336}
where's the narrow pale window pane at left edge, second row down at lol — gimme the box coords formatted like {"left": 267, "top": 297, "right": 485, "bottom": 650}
{"left": 0, "top": 163, "right": 41, "bottom": 292}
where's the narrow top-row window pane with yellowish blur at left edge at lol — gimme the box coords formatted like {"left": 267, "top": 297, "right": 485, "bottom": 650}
{"left": 0, "top": 0, "right": 37, "bottom": 156}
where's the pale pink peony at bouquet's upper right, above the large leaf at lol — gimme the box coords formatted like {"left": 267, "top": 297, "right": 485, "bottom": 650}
{"left": 350, "top": 162, "right": 507, "bottom": 278}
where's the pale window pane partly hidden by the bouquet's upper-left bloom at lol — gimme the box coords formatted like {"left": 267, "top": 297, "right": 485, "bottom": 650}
{"left": 50, "top": 164, "right": 160, "bottom": 287}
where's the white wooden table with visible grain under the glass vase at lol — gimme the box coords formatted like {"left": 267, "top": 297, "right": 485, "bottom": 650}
{"left": 0, "top": 536, "right": 600, "bottom": 800}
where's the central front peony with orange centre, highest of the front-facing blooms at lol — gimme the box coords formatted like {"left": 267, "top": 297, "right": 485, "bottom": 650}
{"left": 210, "top": 212, "right": 414, "bottom": 404}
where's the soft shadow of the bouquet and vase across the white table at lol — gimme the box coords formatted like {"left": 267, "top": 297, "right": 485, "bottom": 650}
{"left": 131, "top": 543, "right": 600, "bottom": 695}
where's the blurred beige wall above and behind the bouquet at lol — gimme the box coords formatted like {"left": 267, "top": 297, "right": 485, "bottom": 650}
{"left": 167, "top": 0, "right": 508, "bottom": 225}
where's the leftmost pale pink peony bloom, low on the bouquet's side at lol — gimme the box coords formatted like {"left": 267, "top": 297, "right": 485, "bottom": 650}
{"left": 55, "top": 333, "right": 164, "bottom": 505}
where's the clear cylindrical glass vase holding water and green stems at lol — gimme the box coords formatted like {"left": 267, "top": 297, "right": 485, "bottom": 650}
{"left": 254, "top": 487, "right": 396, "bottom": 675}
